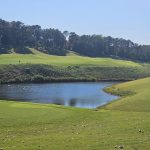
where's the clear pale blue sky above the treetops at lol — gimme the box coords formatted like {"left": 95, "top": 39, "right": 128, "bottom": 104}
{"left": 0, "top": 0, "right": 150, "bottom": 45}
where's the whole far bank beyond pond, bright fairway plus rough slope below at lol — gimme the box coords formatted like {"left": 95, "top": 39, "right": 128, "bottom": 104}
{"left": 0, "top": 48, "right": 150, "bottom": 83}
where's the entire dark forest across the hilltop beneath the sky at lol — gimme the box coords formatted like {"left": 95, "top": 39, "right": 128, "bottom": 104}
{"left": 0, "top": 19, "right": 150, "bottom": 62}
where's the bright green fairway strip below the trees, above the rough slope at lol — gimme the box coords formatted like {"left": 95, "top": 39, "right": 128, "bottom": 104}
{"left": 0, "top": 49, "right": 141, "bottom": 67}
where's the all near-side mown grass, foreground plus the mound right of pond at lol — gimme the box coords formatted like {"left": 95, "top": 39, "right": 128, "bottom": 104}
{"left": 0, "top": 78, "right": 150, "bottom": 150}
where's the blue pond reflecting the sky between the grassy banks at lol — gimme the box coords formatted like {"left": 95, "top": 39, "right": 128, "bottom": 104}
{"left": 0, "top": 82, "right": 118, "bottom": 108}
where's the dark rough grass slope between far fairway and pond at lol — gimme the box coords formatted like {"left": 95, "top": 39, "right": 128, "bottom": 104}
{"left": 0, "top": 64, "right": 150, "bottom": 83}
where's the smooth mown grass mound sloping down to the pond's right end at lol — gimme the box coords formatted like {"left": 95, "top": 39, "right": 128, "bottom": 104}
{"left": 106, "top": 78, "right": 150, "bottom": 112}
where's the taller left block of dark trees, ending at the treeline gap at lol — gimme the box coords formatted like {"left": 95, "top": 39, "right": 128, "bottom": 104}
{"left": 0, "top": 20, "right": 66, "bottom": 55}
